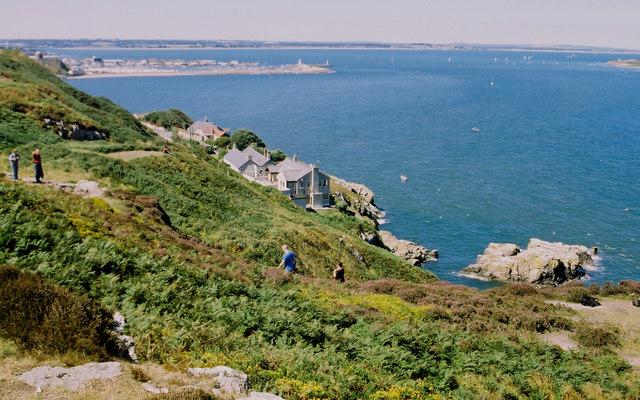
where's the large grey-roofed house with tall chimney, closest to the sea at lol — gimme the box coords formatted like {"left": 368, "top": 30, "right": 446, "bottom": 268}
{"left": 267, "top": 155, "right": 331, "bottom": 209}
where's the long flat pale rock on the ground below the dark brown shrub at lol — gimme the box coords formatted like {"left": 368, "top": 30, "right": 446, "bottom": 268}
{"left": 19, "top": 362, "right": 122, "bottom": 392}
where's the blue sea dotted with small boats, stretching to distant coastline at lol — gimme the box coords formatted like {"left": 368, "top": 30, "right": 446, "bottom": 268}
{"left": 56, "top": 49, "right": 640, "bottom": 287}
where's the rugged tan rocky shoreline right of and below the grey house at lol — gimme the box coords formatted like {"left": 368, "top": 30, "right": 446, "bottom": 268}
{"left": 331, "top": 176, "right": 438, "bottom": 266}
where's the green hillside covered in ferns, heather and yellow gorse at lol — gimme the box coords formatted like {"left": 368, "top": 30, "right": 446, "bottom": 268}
{"left": 0, "top": 52, "right": 640, "bottom": 400}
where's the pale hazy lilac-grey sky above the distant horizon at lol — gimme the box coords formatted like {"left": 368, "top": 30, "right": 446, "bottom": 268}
{"left": 0, "top": 0, "right": 640, "bottom": 49}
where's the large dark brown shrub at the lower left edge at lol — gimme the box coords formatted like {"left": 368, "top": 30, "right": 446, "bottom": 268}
{"left": 0, "top": 266, "right": 112, "bottom": 358}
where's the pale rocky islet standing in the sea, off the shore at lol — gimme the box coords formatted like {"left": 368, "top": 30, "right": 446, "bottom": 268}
{"left": 463, "top": 239, "right": 597, "bottom": 285}
